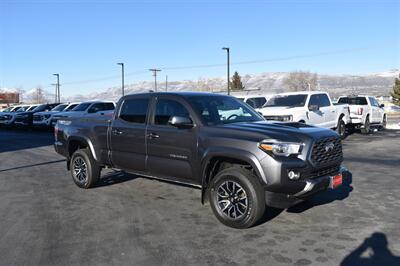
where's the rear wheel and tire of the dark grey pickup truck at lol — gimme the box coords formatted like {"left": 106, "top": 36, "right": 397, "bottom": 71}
{"left": 70, "top": 148, "right": 101, "bottom": 189}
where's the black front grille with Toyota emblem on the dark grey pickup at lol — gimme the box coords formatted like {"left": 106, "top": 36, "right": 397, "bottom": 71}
{"left": 311, "top": 137, "right": 343, "bottom": 166}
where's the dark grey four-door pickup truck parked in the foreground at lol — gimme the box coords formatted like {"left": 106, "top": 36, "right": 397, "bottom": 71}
{"left": 55, "top": 92, "right": 347, "bottom": 228}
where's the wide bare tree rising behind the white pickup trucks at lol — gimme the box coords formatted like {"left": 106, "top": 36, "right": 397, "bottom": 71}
{"left": 283, "top": 71, "right": 318, "bottom": 91}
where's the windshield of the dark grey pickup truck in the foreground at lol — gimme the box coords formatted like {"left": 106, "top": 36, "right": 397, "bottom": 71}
{"left": 188, "top": 96, "right": 264, "bottom": 126}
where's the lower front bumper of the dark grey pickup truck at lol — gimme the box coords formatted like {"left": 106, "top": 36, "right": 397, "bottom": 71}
{"left": 265, "top": 166, "right": 351, "bottom": 209}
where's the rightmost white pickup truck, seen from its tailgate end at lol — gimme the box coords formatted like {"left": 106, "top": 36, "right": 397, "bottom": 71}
{"left": 338, "top": 95, "right": 387, "bottom": 134}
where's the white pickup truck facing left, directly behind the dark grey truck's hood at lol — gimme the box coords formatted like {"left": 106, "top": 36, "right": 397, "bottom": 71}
{"left": 259, "top": 91, "right": 350, "bottom": 137}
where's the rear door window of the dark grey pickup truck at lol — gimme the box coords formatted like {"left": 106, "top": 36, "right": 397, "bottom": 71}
{"left": 119, "top": 98, "right": 150, "bottom": 124}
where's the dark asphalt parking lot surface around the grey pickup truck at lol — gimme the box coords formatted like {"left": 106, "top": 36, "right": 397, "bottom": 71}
{"left": 0, "top": 129, "right": 400, "bottom": 265}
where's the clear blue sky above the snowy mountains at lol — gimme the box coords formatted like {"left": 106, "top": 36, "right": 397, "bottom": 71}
{"left": 0, "top": 0, "right": 400, "bottom": 95}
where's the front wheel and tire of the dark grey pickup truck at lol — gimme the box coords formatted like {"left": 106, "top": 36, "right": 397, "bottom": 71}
{"left": 209, "top": 166, "right": 265, "bottom": 229}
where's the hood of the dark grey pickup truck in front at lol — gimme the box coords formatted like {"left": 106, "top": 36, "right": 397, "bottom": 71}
{"left": 218, "top": 121, "right": 338, "bottom": 142}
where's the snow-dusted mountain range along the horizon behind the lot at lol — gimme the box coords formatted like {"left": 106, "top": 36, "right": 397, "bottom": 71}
{"left": 68, "top": 69, "right": 400, "bottom": 101}
